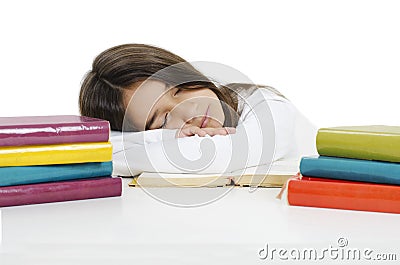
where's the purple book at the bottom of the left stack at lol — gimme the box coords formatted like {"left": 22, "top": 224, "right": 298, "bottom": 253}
{"left": 0, "top": 176, "right": 122, "bottom": 207}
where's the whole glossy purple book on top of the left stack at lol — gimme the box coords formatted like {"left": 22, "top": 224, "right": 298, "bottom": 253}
{"left": 0, "top": 115, "right": 110, "bottom": 146}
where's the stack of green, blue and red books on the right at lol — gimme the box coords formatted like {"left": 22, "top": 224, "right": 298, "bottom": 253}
{"left": 287, "top": 125, "right": 400, "bottom": 213}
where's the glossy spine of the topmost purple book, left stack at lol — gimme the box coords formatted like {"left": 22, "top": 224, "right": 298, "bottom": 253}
{"left": 0, "top": 120, "right": 110, "bottom": 146}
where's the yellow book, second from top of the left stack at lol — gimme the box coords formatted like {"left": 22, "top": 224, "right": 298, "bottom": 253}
{"left": 0, "top": 142, "right": 112, "bottom": 167}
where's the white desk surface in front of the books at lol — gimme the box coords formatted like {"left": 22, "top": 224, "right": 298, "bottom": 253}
{"left": 0, "top": 176, "right": 400, "bottom": 265}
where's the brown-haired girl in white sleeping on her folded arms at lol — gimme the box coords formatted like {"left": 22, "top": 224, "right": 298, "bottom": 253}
{"left": 79, "top": 44, "right": 316, "bottom": 175}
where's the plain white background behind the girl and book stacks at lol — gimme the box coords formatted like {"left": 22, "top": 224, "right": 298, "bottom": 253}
{"left": 0, "top": 0, "right": 400, "bottom": 127}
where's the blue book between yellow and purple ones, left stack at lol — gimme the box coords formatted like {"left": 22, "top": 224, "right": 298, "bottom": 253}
{"left": 0, "top": 161, "right": 112, "bottom": 186}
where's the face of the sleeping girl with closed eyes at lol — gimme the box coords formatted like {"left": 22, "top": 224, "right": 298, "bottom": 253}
{"left": 124, "top": 80, "right": 225, "bottom": 130}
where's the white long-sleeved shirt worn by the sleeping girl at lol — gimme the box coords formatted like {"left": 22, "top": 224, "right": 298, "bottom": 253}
{"left": 110, "top": 88, "right": 317, "bottom": 176}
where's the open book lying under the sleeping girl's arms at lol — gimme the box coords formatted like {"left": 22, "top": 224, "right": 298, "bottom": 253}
{"left": 129, "top": 160, "right": 299, "bottom": 187}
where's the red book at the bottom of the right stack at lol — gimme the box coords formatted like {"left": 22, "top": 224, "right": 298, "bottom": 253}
{"left": 287, "top": 174, "right": 400, "bottom": 213}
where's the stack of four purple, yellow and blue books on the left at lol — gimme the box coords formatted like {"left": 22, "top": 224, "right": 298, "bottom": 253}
{"left": 0, "top": 115, "right": 122, "bottom": 207}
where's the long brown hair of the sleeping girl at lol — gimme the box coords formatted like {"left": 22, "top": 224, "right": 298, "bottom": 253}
{"left": 79, "top": 44, "right": 282, "bottom": 131}
